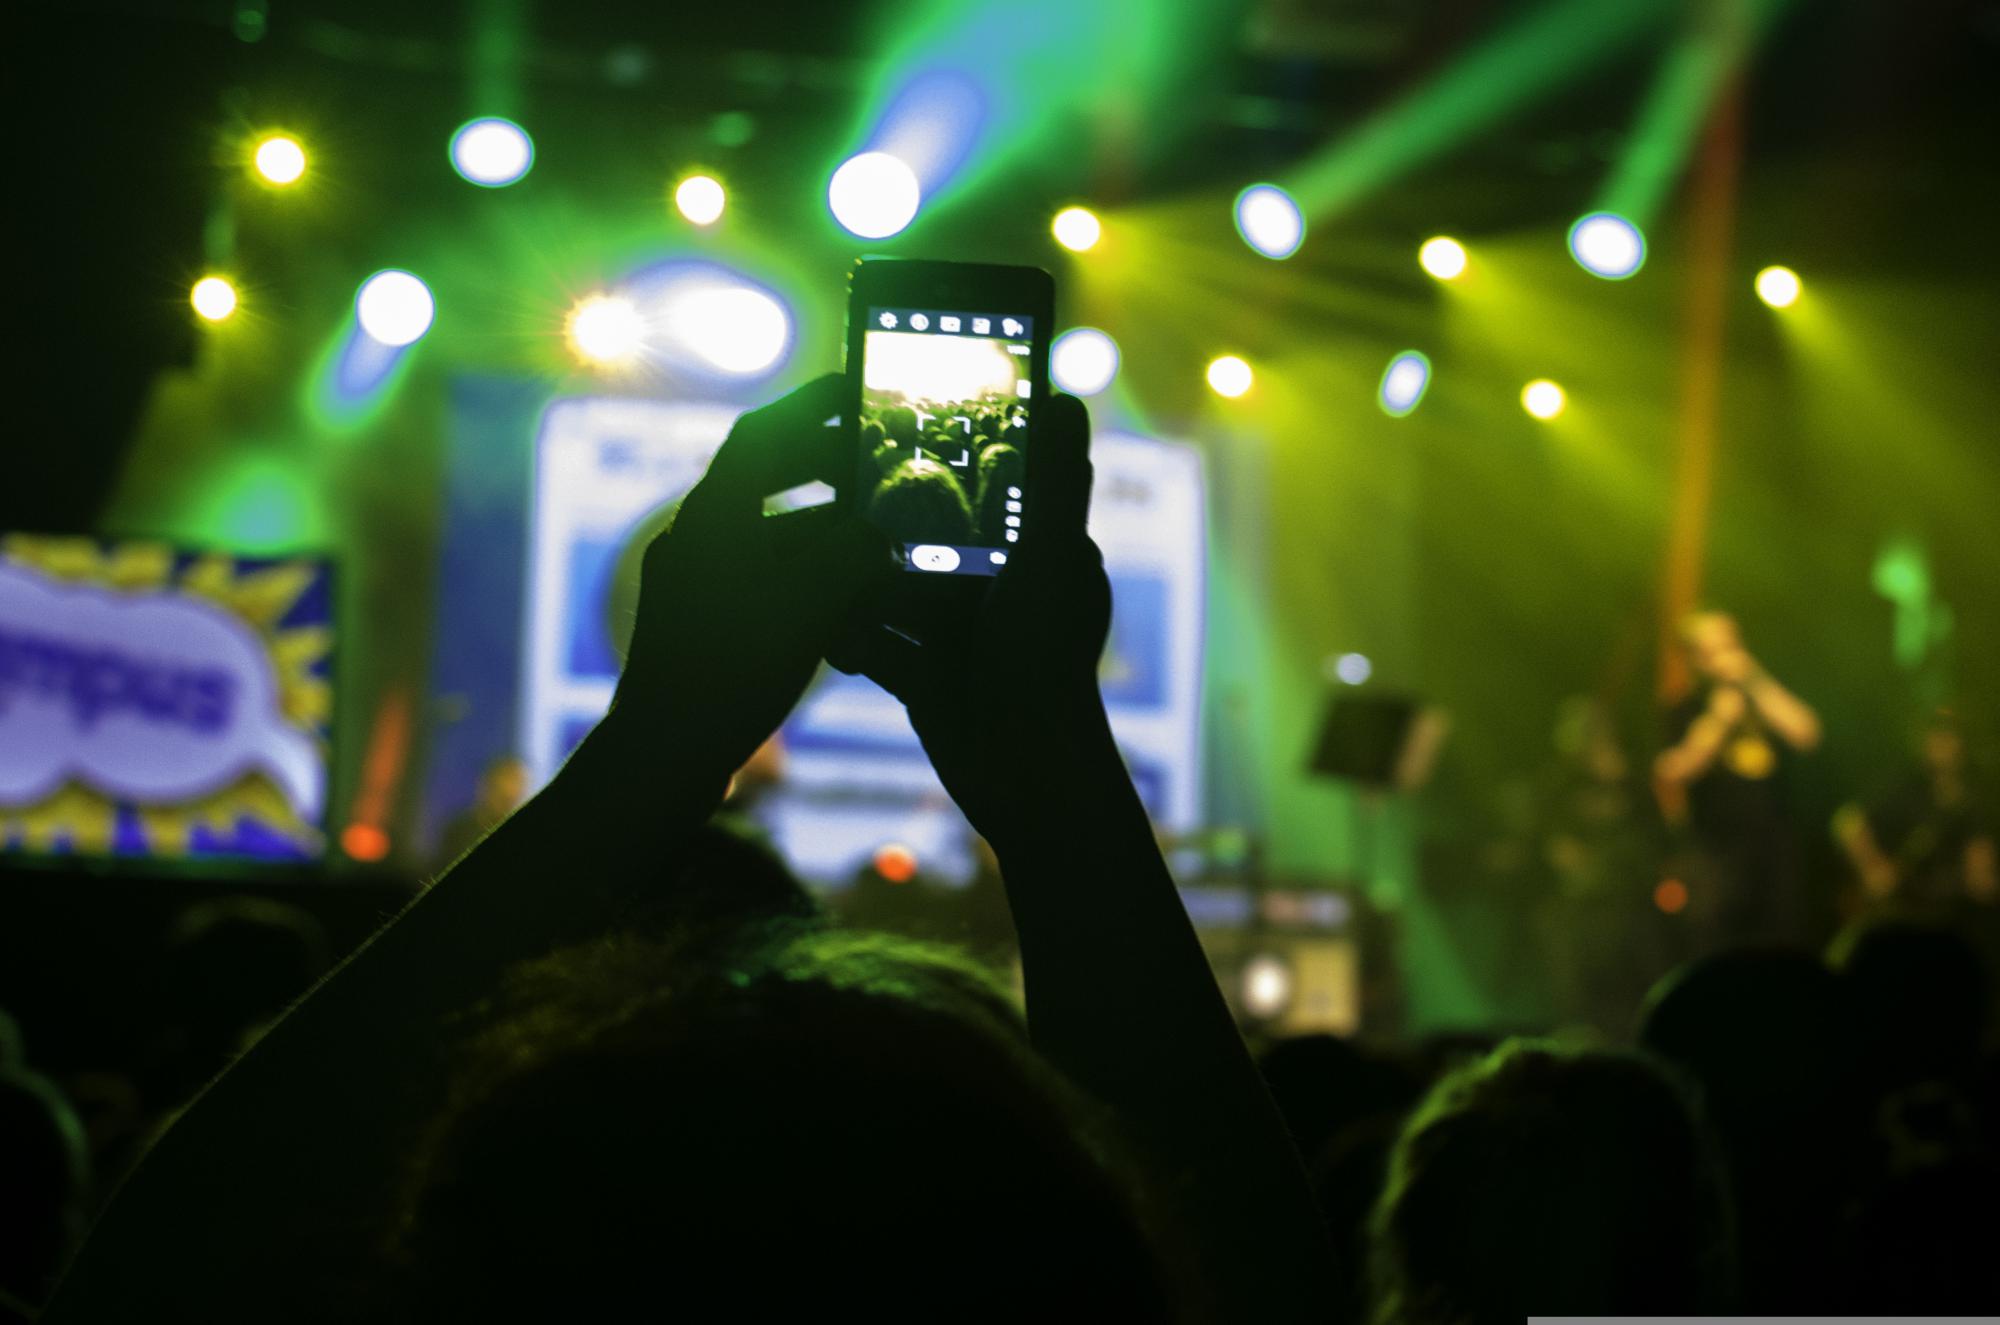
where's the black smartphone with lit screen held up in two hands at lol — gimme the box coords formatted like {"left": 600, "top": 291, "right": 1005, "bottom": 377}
{"left": 844, "top": 258, "right": 1056, "bottom": 596}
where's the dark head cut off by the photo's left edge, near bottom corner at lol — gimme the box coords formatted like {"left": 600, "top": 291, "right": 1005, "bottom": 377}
{"left": 0, "top": 1069, "right": 90, "bottom": 1303}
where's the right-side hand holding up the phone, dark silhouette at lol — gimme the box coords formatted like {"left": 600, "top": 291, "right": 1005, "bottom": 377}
{"left": 828, "top": 396, "right": 1116, "bottom": 847}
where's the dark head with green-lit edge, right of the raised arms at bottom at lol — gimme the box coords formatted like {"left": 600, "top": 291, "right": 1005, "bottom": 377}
{"left": 1372, "top": 1041, "right": 1728, "bottom": 1323}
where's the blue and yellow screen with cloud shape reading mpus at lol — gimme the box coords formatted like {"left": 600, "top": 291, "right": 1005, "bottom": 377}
{"left": 0, "top": 534, "right": 332, "bottom": 863}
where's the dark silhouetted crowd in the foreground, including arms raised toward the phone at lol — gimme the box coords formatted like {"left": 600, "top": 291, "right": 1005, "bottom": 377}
{"left": 0, "top": 378, "right": 2000, "bottom": 1323}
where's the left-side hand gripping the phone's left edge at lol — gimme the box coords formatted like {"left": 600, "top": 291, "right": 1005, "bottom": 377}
{"left": 612, "top": 374, "right": 894, "bottom": 781}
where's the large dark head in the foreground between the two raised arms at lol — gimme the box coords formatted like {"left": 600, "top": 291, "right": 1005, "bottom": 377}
{"left": 402, "top": 921, "right": 1168, "bottom": 1321}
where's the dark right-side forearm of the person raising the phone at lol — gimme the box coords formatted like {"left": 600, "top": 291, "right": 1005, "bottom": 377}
{"left": 1000, "top": 731, "right": 1334, "bottom": 1321}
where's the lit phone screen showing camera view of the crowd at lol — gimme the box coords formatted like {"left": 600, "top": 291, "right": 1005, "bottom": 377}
{"left": 858, "top": 308, "right": 1034, "bottom": 574}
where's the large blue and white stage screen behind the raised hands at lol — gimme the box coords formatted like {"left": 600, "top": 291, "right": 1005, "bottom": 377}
{"left": 424, "top": 382, "right": 1204, "bottom": 883}
